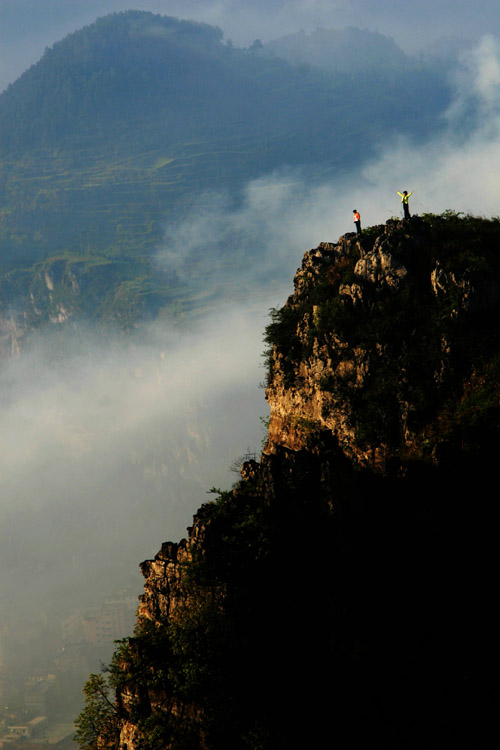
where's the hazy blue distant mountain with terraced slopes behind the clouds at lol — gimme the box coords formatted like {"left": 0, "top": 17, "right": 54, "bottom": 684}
{"left": 0, "top": 11, "right": 450, "bottom": 340}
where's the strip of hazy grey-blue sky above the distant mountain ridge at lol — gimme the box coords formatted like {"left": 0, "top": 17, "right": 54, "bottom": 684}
{"left": 0, "top": 0, "right": 500, "bottom": 89}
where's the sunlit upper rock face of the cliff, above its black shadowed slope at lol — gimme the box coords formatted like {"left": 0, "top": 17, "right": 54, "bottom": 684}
{"left": 266, "top": 218, "right": 500, "bottom": 471}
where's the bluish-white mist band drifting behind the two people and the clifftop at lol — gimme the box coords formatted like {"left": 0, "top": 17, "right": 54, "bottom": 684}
{"left": 157, "top": 36, "right": 500, "bottom": 290}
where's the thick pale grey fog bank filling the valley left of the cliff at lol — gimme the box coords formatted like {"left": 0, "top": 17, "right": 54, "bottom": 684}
{"left": 0, "top": 305, "right": 267, "bottom": 616}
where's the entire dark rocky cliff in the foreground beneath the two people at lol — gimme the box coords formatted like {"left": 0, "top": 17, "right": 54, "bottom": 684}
{"left": 77, "top": 212, "right": 500, "bottom": 750}
